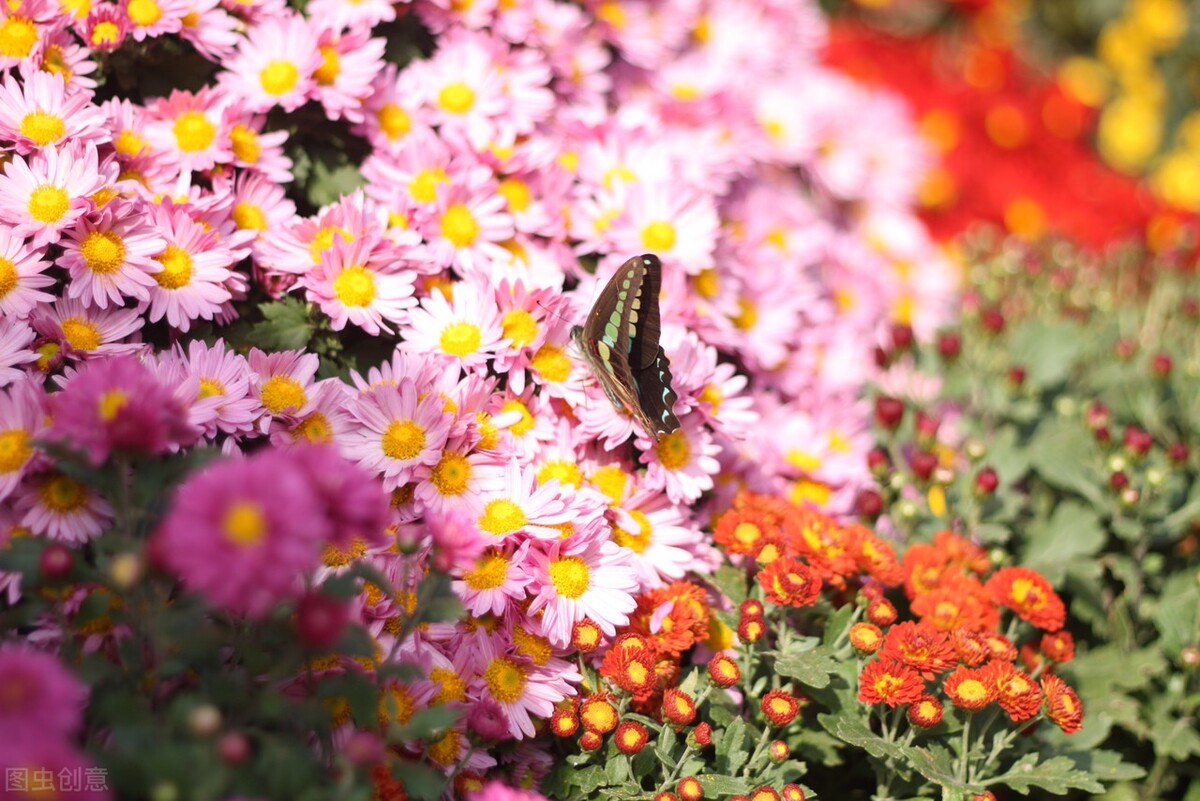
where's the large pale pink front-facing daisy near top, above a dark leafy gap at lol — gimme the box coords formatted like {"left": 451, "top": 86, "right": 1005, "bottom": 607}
{"left": 217, "top": 12, "right": 322, "bottom": 112}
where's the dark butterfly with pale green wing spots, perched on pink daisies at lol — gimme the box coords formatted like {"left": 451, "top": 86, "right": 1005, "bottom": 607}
{"left": 571, "top": 253, "right": 679, "bottom": 441}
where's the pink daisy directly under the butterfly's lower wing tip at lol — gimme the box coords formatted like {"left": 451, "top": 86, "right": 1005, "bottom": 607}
{"left": 637, "top": 415, "right": 721, "bottom": 504}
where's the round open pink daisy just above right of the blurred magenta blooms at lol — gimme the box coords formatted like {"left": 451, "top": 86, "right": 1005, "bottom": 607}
{"left": 338, "top": 379, "right": 452, "bottom": 490}
